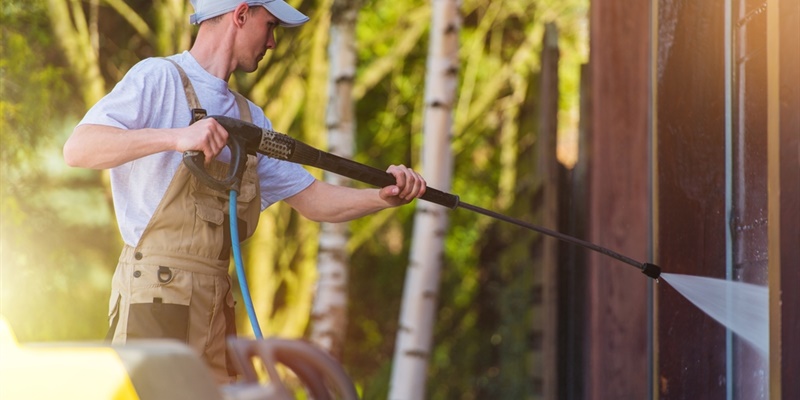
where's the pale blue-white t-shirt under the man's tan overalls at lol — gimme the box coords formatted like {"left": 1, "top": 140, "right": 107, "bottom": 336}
{"left": 80, "top": 52, "right": 314, "bottom": 246}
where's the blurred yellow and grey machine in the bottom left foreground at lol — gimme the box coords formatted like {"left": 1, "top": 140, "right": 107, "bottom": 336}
{"left": 0, "top": 317, "right": 222, "bottom": 400}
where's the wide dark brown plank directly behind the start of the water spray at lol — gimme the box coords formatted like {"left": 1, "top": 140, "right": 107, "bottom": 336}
{"left": 654, "top": 0, "right": 730, "bottom": 399}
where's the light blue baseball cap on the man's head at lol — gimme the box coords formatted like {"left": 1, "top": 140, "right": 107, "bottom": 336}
{"left": 189, "top": 0, "right": 308, "bottom": 27}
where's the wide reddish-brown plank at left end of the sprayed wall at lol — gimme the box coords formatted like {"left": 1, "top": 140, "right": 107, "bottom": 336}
{"left": 586, "top": 0, "right": 650, "bottom": 399}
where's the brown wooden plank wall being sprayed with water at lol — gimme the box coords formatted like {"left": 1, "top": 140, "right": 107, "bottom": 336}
{"left": 576, "top": 0, "right": 800, "bottom": 399}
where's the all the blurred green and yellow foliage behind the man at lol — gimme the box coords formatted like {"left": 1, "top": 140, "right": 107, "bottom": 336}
{"left": 0, "top": 0, "right": 588, "bottom": 399}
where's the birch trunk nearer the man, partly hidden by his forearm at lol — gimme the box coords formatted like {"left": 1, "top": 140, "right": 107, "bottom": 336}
{"left": 311, "top": 0, "right": 361, "bottom": 359}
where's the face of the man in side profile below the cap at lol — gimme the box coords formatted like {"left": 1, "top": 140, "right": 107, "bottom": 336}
{"left": 239, "top": 6, "right": 280, "bottom": 72}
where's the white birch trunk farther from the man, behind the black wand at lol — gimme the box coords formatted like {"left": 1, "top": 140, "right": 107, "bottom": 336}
{"left": 389, "top": 0, "right": 461, "bottom": 399}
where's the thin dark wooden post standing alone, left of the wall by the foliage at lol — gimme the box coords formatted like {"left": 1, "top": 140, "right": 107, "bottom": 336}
{"left": 538, "top": 23, "right": 559, "bottom": 400}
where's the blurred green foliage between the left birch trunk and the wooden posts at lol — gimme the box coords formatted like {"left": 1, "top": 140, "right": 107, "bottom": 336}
{"left": 345, "top": 1, "right": 588, "bottom": 399}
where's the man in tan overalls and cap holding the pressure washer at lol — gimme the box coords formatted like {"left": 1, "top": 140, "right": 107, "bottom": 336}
{"left": 64, "top": 0, "right": 426, "bottom": 382}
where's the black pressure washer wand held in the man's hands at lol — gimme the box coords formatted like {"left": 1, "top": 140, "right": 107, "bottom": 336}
{"left": 184, "top": 116, "right": 661, "bottom": 279}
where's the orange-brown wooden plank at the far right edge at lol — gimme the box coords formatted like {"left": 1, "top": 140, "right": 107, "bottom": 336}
{"left": 767, "top": 0, "right": 800, "bottom": 399}
